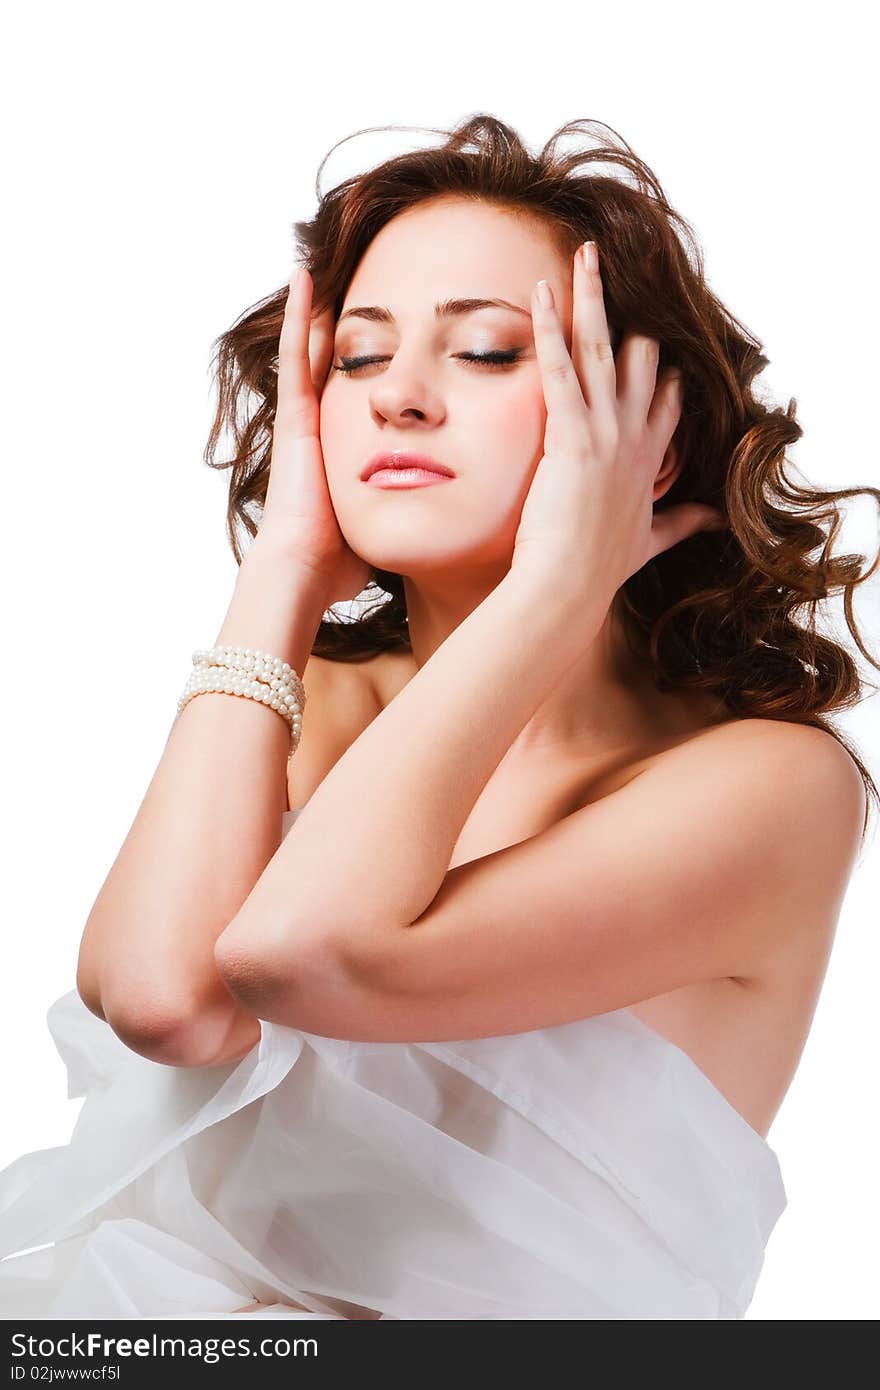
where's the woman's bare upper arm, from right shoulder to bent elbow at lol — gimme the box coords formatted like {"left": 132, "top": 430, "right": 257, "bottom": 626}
{"left": 291, "top": 720, "right": 865, "bottom": 1041}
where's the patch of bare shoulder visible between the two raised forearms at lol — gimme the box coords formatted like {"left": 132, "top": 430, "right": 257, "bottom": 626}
{"left": 288, "top": 652, "right": 389, "bottom": 808}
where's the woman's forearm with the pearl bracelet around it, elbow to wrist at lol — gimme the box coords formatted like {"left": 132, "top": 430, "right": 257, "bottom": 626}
{"left": 76, "top": 541, "right": 325, "bottom": 1059}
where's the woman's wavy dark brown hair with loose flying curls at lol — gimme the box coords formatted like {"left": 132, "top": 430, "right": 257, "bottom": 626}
{"left": 204, "top": 114, "right": 880, "bottom": 840}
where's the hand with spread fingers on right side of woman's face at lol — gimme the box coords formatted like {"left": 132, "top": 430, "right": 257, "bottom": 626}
{"left": 513, "top": 241, "right": 726, "bottom": 603}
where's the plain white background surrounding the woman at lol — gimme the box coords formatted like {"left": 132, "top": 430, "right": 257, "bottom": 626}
{"left": 0, "top": 0, "right": 880, "bottom": 1319}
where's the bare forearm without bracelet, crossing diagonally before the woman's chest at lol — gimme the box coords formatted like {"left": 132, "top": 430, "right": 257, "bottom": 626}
{"left": 224, "top": 571, "right": 608, "bottom": 972}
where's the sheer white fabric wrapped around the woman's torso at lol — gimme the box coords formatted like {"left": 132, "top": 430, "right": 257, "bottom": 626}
{"left": 0, "top": 812, "right": 787, "bottom": 1319}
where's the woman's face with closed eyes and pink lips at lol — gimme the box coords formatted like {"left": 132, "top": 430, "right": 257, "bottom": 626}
{"left": 320, "top": 196, "right": 571, "bottom": 578}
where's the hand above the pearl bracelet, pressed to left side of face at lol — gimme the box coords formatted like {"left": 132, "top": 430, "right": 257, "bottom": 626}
{"left": 254, "top": 267, "right": 370, "bottom": 605}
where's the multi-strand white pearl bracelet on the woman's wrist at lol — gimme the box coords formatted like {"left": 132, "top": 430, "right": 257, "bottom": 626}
{"left": 175, "top": 646, "right": 306, "bottom": 760}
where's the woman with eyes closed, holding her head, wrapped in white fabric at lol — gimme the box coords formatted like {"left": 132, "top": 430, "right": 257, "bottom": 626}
{"left": 0, "top": 117, "right": 880, "bottom": 1319}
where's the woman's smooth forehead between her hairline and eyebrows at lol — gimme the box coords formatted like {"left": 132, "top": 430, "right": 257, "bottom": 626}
{"left": 342, "top": 196, "right": 564, "bottom": 310}
